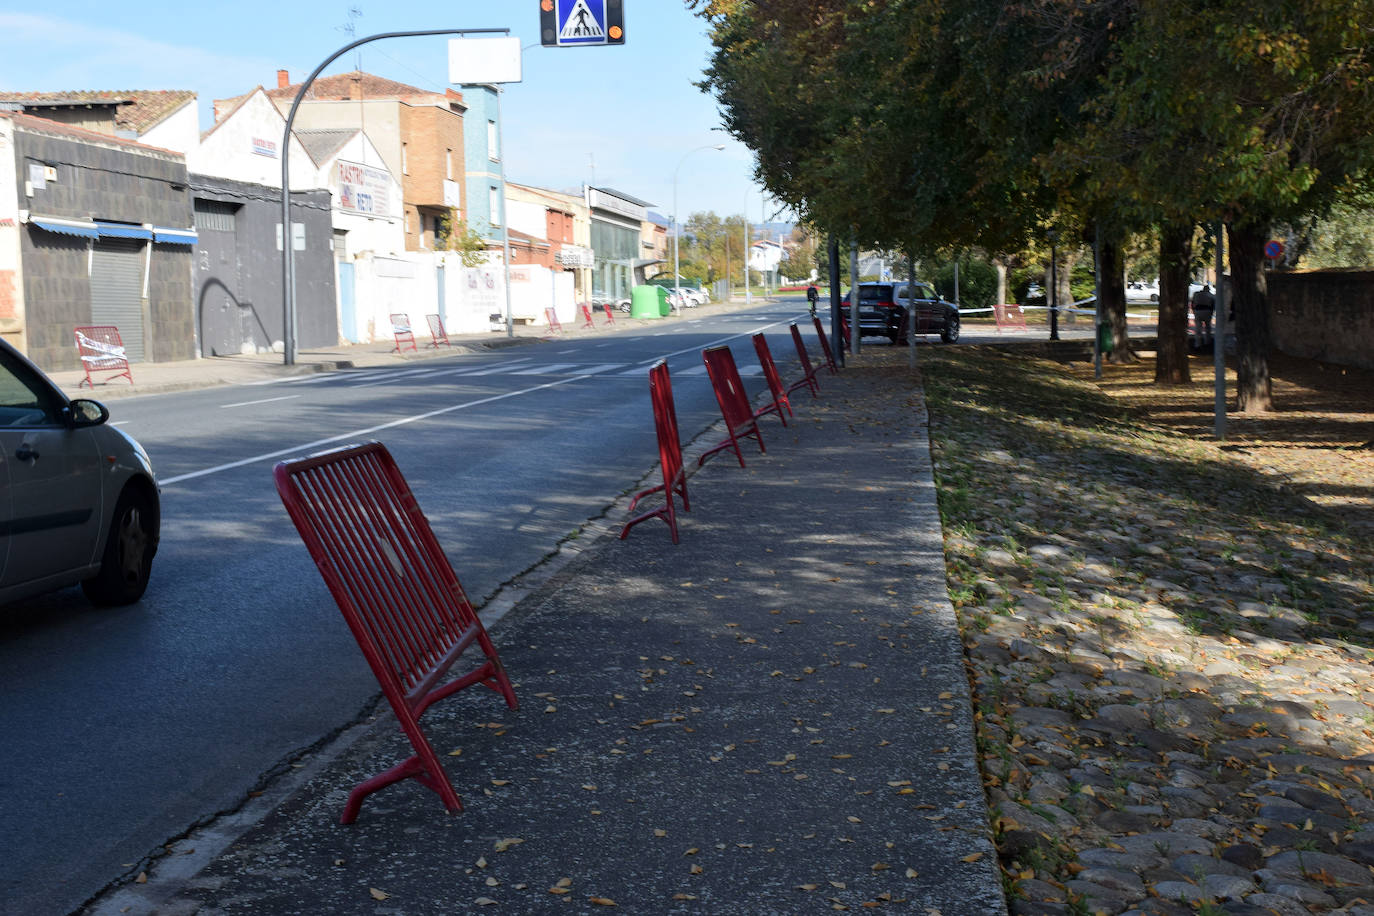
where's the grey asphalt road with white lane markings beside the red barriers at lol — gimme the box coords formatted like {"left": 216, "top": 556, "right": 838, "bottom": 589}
{"left": 0, "top": 302, "right": 815, "bottom": 915}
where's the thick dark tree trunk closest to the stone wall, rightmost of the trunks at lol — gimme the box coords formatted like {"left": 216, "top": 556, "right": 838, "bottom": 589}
{"left": 1219, "top": 220, "right": 1274, "bottom": 413}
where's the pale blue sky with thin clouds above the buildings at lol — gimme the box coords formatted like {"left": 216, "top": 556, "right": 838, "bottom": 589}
{"left": 0, "top": 0, "right": 775, "bottom": 222}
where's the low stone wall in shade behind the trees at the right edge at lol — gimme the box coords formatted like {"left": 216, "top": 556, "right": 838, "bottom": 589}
{"left": 1268, "top": 271, "right": 1374, "bottom": 369}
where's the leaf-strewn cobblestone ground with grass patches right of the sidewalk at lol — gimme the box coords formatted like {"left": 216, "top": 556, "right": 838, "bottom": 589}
{"left": 906, "top": 347, "right": 1374, "bottom": 916}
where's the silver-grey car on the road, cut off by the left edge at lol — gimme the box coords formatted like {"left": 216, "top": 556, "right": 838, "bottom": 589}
{"left": 0, "top": 341, "right": 161, "bottom": 604}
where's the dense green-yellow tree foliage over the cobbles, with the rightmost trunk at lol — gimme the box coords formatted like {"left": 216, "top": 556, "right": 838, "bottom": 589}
{"left": 687, "top": 0, "right": 1374, "bottom": 409}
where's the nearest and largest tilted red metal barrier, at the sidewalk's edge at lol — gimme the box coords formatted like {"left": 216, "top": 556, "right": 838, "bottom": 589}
{"left": 272, "top": 442, "right": 518, "bottom": 824}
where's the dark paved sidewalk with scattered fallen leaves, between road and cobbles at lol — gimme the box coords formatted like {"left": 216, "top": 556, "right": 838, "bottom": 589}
{"left": 93, "top": 346, "right": 1006, "bottom": 916}
